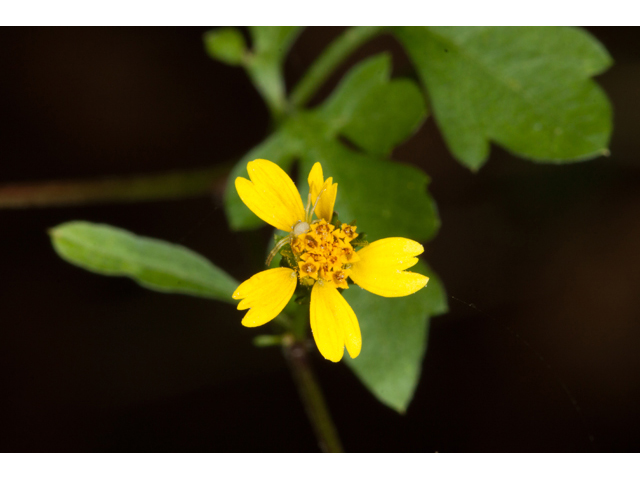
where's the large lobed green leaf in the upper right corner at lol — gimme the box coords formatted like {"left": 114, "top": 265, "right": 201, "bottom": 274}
{"left": 394, "top": 27, "right": 612, "bottom": 170}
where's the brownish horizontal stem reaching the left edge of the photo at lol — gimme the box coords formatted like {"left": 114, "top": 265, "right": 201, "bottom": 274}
{"left": 0, "top": 164, "right": 231, "bottom": 209}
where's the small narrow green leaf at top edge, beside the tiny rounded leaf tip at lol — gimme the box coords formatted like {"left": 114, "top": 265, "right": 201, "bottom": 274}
{"left": 246, "top": 27, "right": 302, "bottom": 115}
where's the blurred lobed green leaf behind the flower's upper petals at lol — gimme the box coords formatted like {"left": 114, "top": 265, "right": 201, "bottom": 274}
{"left": 225, "top": 55, "right": 440, "bottom": 244}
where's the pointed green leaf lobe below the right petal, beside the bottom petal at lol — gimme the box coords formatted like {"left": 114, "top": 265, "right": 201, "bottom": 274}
{"left": 343, "top": 261, "right": 447, "bottom": 413}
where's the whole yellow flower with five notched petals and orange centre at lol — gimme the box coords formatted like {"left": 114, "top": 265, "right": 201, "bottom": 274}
{"left": 233, "top": 159, "right": 429, "bottom": 362}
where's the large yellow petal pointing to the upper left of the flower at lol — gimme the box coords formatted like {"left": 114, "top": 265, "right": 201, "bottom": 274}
{"left": 235, "top": 159, "right": 304, "bottom": 232}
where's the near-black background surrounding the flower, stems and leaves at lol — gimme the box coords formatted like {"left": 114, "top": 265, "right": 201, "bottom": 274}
{"left": 0, "top": 28, "right": 640, "bottom": 452}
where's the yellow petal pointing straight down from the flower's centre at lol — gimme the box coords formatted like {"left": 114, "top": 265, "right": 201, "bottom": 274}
{"left": 311, "top": 282, "right": 362, "bottom": 362}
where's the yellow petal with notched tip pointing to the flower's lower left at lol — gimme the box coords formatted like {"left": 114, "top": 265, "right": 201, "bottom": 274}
{"left": 232, "top": 268, "right": 297, "bottom": 327}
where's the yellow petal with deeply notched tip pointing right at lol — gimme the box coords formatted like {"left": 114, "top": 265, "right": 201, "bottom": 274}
{"left": 350, "top": 237, "right": 429, "bottom": 297}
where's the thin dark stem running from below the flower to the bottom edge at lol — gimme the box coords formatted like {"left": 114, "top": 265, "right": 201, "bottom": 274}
{"left": 284, "top": 341, "right": 343, "bottom": 453}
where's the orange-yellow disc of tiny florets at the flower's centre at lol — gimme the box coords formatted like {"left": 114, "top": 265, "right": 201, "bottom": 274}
{"left": 291, "top": 220, "right": 359, "bottom": 288}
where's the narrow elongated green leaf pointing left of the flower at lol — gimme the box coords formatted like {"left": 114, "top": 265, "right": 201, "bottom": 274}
{"left": 49, "top": 221, "right": 238, "bottom": 303}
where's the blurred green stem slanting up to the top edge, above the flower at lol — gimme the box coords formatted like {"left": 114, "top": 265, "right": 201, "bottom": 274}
{"left": 291, "top": 27, "right": 385, "bottom": 108}
